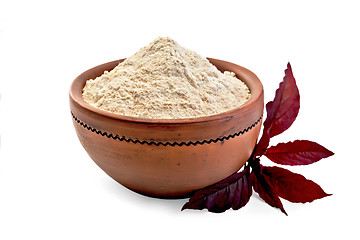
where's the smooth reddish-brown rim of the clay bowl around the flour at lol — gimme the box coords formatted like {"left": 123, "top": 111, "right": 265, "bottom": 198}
{"left": 69, "top": 58, "right": 263, "bottom": 125}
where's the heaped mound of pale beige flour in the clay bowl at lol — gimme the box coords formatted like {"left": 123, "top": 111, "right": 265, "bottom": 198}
{"left": 83, "top": 37, "right": 250, "bottom": 119}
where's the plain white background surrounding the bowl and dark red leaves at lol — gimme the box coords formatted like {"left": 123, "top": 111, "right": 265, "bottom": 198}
{"left": 0, "top": 0, "right": 360, "bottom": 240}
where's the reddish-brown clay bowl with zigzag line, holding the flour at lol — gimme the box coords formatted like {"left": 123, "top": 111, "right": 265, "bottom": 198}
{"left": 70, "top": 58, "right": 264, "bottom": 198}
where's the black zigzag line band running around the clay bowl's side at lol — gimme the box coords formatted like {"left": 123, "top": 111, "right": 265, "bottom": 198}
{"left": 71, "top": 112, "right": 262, "bottom": 146}
